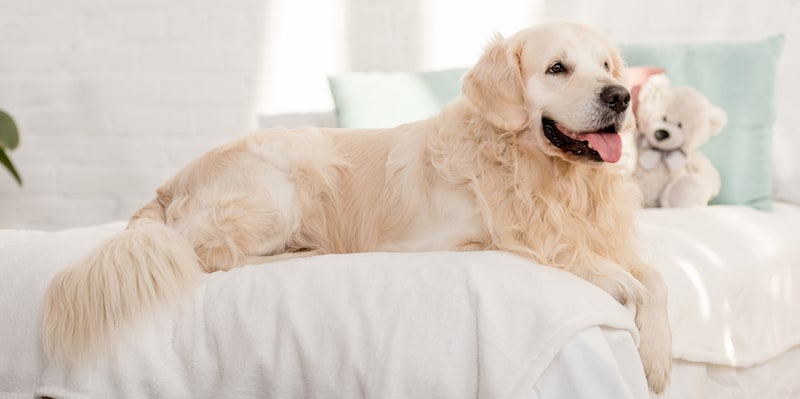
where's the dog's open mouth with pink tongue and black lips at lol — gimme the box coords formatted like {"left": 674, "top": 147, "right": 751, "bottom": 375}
{"left": 542, "top": 118, "right": 622, "bottom": 163}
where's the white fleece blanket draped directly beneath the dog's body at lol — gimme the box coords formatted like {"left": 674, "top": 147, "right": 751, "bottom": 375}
{"left": 0, "top": 226, "right": 638, "bottom": 398}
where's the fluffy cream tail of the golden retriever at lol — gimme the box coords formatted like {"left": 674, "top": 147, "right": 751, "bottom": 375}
{"left": 42, "top": 219, "right": 202, "bottom": 363}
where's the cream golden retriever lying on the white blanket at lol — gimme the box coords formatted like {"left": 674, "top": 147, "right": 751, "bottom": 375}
{"left": 42, "top": 22, "right": 671, "bottom": 392}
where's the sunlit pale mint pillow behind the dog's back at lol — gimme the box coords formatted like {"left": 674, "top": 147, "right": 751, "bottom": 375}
{"left": 328, "top": 69, "right": 466, "bottom": 128}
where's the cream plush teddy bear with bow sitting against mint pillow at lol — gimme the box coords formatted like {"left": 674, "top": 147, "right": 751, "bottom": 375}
{"left": 634, "top": 74, "right": 728, "bottom": 208}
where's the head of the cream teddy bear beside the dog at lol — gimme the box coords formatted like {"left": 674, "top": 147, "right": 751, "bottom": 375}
{"left": 636, "top": 74, "right": 728, "bottom": 153}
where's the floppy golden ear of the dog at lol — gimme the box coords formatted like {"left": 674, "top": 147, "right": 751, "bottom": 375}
{"left": 462, "top": 35, "right": 528, "bottom": 132}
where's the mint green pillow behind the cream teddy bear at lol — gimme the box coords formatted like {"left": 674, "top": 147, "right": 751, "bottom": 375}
{"left": 620, "top": 35, "right": 784, "bottom": 210}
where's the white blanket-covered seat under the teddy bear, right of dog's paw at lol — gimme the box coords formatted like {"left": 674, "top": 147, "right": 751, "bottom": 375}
{"left": 640, "top": 202, "right": 800, "bottom": 367}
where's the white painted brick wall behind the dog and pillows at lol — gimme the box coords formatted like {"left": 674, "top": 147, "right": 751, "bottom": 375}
{"left": 0, "top": 0, "right": 800, "bottom": 229}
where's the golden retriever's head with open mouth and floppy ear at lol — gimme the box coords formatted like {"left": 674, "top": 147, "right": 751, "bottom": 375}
{"left": 463, "top": 22, "right": 634, "bottom": 163}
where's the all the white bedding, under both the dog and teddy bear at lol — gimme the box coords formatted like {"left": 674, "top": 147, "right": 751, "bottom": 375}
{"left": 0, "top": 204, "right": 800, "bottom": 398}
